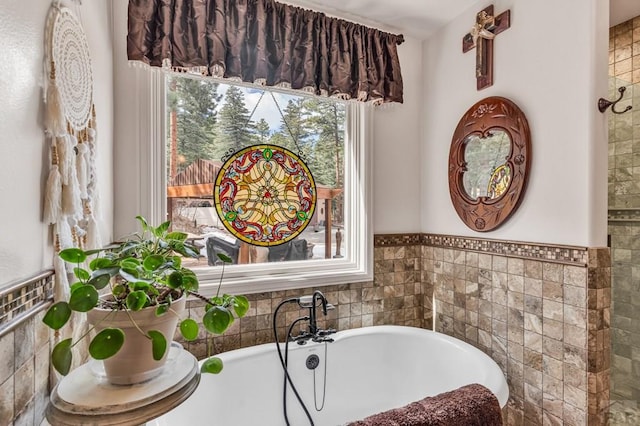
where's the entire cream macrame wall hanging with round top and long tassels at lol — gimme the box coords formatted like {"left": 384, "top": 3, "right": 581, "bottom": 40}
{"left": 43, "top": 1, "right": 101, "bottom": 300}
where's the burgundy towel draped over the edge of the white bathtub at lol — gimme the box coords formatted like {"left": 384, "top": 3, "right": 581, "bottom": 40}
{"left": 347, "top": 383, "right": 502, "bottom": 426}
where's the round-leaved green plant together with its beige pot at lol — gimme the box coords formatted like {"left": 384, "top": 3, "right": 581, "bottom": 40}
{"left": 43, "top": 216, "right": 249, "bottom": 384}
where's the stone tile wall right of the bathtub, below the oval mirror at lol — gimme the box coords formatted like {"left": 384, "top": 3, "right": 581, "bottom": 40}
{"left": 422, "top": 236, "right": 610, "bottom": 426}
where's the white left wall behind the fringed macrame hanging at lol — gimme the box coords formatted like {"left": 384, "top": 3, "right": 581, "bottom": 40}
{"left": 0, "top": 0, "right": 113, "bottom": 287}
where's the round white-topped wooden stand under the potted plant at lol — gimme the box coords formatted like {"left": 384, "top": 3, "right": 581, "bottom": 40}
{"left": 45, "top": 344, "right": 200, "bottom": 426}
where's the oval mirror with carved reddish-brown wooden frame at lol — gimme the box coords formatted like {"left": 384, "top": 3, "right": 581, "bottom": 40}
{"left": 449, "top": 96, "right": 531, "bottom": 232}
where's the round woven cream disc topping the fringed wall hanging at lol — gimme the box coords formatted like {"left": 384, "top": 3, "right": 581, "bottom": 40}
{"left": 51, "top": 7, "right": 93, "bottom": 131}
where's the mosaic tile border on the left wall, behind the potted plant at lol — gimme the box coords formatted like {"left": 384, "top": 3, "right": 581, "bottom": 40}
{"left": 0, "top": 270, "right": 54, "bottom": 337}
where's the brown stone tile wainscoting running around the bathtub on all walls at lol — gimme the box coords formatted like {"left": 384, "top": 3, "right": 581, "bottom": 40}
{"left": 0, "top": 234, "right": 611, "bottom": 425}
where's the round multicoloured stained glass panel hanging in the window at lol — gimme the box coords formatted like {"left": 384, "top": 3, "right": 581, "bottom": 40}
{"left": 213, "top": 145, "right": 317, "bottom": 246}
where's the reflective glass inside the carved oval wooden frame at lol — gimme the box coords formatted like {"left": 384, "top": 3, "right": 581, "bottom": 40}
{"left": 462, "top": 129, "right": 511, "bottom": 200}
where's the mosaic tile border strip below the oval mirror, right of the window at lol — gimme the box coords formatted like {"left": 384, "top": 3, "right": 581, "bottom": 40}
{"left": 373, "top": 233, "right": 592, "bottom": 266}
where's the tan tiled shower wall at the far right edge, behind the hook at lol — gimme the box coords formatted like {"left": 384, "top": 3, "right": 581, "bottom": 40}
{"left": 608, "top": 13, "right": 640, "bottom": 424}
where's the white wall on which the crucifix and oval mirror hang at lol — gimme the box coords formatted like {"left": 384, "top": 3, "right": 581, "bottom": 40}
{"left": 421, "top": 0, "right": 608, "bottom": 246}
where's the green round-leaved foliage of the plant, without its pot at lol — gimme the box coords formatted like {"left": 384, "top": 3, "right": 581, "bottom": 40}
{"left": 43, "top": 216, "right": 249, "bottom": 375}
